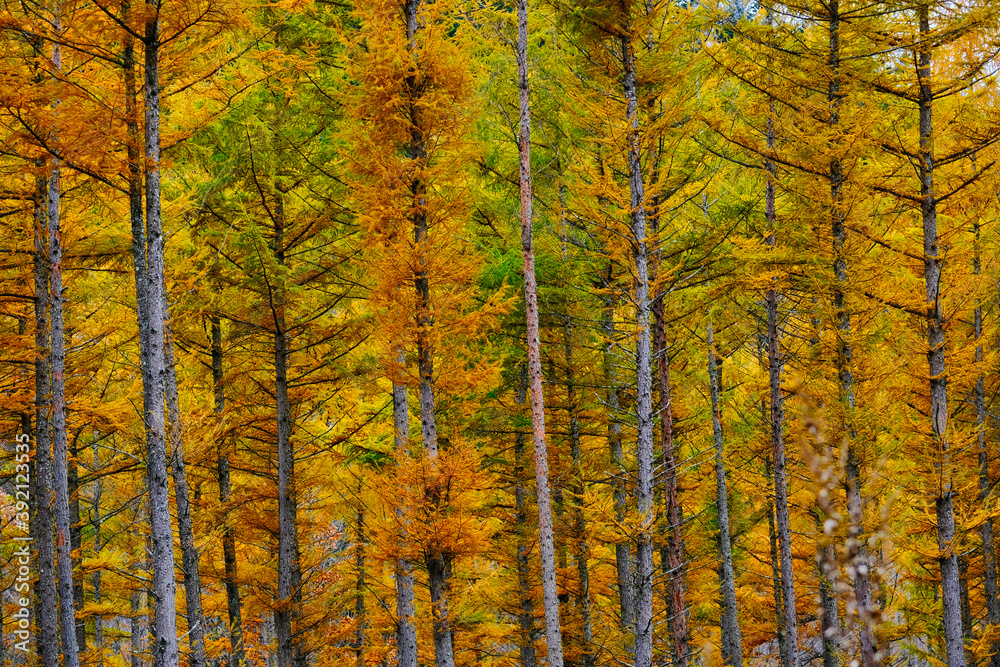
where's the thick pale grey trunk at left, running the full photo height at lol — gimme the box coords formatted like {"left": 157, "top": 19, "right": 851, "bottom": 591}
{"left": 140, "top": 7, "right": 179, "bottom": 667}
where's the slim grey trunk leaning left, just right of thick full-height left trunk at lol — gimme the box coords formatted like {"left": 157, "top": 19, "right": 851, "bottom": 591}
{"left": 161, "top": 314, "right": 206, "bottom": 667}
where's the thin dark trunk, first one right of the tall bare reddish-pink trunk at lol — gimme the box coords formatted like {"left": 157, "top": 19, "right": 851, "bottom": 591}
{"left": 563, "top": 324, "right": 594, "bottom": 667}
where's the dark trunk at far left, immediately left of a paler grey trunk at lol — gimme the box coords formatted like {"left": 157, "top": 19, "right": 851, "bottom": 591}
{"left": 30, "top": 171, "right": 59, "bottom": 667}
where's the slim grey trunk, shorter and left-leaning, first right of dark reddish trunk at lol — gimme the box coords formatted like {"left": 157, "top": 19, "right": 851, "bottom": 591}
{"left": 708, "top": 324, "right": 743, "bottom": 667}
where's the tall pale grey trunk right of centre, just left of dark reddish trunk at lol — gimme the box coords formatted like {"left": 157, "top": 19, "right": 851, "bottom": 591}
{"left": 621, "top": 26, "right": 656, "bottom": 667}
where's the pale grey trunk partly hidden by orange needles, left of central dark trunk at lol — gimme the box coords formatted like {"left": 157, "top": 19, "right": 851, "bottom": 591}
{"left": 392, "top": 350, "right": 417, "bottom": 667}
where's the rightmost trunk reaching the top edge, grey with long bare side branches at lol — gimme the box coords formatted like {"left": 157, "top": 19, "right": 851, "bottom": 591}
{"left": 917, "top": 2, "right": 966, "bottom": 667}
